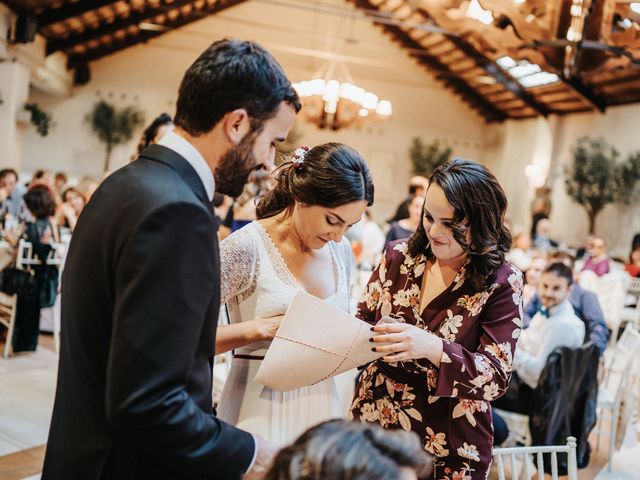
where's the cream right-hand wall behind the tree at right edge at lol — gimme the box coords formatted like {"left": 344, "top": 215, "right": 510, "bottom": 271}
{"left": 483, "top": 105, "right": 640, "bottom": 257}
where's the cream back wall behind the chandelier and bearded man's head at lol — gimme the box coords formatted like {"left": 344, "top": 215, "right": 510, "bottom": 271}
{"left": 23, "top": 0, "right": 485, "bottom": 218}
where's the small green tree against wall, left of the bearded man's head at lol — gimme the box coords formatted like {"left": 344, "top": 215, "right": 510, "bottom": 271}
{"left": 85, "top": 100, "right": 144, "bottom": 171}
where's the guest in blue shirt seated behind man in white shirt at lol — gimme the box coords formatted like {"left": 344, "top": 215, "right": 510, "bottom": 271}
{"left": 523, "top": 253, "right": 609, "bottom": 353}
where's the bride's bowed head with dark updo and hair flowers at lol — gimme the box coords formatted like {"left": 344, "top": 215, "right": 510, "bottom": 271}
{"left": 256, "top": 143, "right": 373, "bottom": 249}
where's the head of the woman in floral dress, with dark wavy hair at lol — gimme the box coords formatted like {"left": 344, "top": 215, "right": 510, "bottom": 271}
{"left": 409, "top": 158, "right": 511, "bottom": 289}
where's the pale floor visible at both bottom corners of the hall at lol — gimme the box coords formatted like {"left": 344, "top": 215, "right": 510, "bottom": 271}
{"left": 0, "top": 335, "right": 640, "bottom": 480}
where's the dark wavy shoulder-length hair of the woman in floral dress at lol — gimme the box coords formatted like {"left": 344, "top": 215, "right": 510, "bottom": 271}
{"left": 408, "top": 158, "right": 511, "bottom": 290}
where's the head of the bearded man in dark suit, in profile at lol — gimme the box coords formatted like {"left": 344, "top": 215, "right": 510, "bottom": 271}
{"left": 173, "top": 40, "right": 301, "bottom": 197}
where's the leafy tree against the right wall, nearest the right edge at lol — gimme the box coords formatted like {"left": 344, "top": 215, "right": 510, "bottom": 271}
{"left": 565, "top": 137, "right": 640, "bottom": 233}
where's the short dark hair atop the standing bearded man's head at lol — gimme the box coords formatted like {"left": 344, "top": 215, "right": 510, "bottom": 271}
{"left": 173, "top": 39, "right": 301, "bottom": 136}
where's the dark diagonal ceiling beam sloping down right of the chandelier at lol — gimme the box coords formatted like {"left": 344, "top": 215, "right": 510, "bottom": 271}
{"left": 351, "top": 0, "right": 507, "bottom": 122}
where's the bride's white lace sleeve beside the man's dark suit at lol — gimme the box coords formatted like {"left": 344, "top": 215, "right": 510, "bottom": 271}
{"left": 220, "top": 225, "right": 258, "bottom": 304}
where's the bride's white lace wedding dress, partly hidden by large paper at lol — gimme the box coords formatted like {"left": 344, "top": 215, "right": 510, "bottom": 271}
{"left": 218, "top": 221, "right": 355, "bottom": 447}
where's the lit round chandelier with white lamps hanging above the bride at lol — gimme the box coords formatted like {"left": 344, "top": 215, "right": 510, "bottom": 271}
{"left": 293, "top": 60, "right": 392, "bottom": 130}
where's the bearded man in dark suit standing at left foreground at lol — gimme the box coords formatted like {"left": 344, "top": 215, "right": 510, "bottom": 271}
{"left": 42, "top": 40, "right": 300, "bottom": 480}
